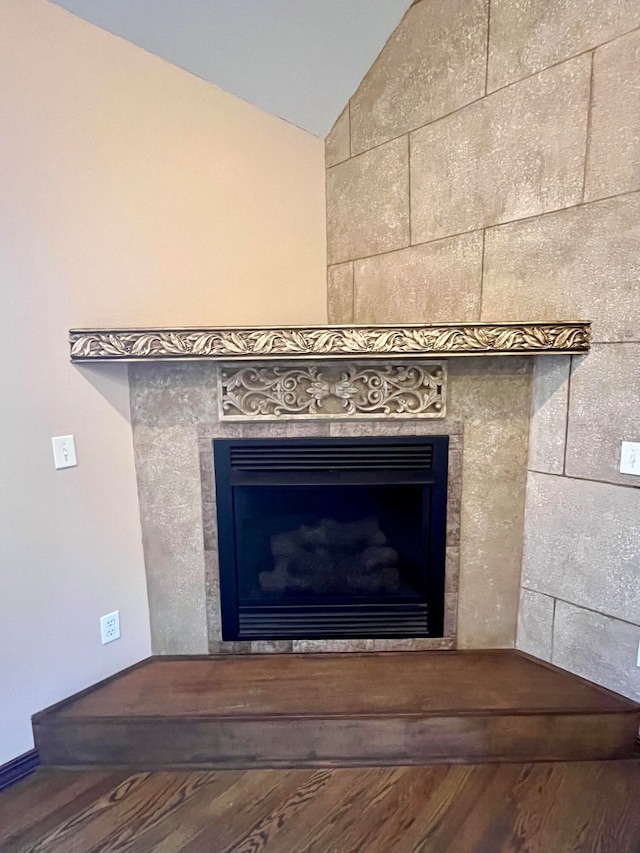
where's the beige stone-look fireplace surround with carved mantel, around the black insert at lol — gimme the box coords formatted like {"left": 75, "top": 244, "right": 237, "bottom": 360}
{"left": 71, "top": 324, "right": 589, "bottom": 654}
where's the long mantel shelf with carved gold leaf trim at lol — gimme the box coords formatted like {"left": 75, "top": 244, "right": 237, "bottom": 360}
{"left": 70, "top": 323, "right": 590, "bottom": 361}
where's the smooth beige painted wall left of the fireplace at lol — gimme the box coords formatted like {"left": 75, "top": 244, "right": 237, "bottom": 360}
{"left": 0, "top": 0, "right": 326, "bottom": 764}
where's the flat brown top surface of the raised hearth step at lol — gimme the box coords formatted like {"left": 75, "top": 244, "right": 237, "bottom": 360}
{"left": 48, "top": 650, "right": 634, "bottom": 719}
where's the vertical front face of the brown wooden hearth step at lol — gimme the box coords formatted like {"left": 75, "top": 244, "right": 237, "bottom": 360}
{"left": 36, "top": 714, "right": 637, "bottom": 770}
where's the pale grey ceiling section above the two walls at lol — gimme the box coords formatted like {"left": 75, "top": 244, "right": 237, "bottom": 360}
{"left": 48, "top": 0, "right": 410, "bottom": 137}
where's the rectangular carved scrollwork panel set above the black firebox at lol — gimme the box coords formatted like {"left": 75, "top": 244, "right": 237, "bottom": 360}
{"left": 218, "top": 362, "right": 446, "bottom": 421}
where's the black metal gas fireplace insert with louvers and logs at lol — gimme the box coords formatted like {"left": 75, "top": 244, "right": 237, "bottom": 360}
{"left": 213, "top": 436, "right": 449, "bottom": 640}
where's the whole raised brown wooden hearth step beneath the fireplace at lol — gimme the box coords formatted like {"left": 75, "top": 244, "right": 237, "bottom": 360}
{"left": 33, "top": 650, "right": 640, "bottom": 770}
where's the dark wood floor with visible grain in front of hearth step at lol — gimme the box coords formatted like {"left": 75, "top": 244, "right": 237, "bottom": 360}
{"left": 0, "top": 760, "right": 640, "bottom": 853}
